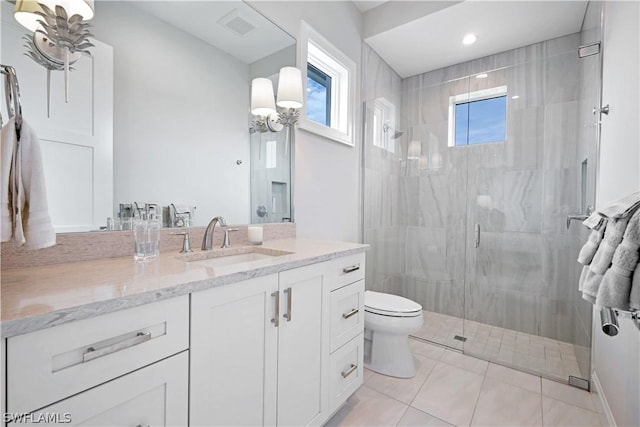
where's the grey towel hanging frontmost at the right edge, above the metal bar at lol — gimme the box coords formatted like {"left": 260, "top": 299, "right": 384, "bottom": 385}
{"left": 596, "top": 210, "right": 640, "bottom": 310}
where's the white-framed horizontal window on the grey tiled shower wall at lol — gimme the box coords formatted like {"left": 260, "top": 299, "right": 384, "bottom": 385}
{"left": 449, "top": 86, "right": 507, "bottom": 147}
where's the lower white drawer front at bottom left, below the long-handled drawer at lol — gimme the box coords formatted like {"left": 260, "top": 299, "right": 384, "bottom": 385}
{"left": 7, "top": 351, "right": 189, "bottom": 426}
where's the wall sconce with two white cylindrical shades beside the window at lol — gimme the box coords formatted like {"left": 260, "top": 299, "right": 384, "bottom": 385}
{"left": 251, "top": 67, "right": 302, "bottom": 132}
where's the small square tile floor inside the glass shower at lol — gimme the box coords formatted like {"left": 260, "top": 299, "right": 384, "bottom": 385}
{"left": 413, "top": 311, "right": 588, "bottom": 381}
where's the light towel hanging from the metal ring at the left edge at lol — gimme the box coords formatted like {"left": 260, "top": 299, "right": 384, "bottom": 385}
{"left": 0, "top": 118, "right": 56, "bottom": 249}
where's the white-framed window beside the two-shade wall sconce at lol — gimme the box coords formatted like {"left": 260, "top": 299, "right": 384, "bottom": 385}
{"left": 298, "top": 22, "right": 357, "bottom": 146}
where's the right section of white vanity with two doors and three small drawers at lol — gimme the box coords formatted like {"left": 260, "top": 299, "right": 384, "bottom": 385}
{"left": 190, "top": 254, "right": 364, "bottom": 426}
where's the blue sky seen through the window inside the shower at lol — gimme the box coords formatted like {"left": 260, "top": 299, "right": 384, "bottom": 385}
{"left": 455, "top": 96, "right": 507, "bottom": 145}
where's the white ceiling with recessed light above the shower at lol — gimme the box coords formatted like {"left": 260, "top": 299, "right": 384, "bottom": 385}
{"left": 362, "top": 0, "right": 587, "bottom": 78}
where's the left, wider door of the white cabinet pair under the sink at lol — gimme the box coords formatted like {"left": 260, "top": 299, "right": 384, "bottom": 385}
{"left": 190, "top": 275, "right": 278, "bottom": 426}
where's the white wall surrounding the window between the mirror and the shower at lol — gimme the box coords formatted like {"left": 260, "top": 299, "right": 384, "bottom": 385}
{"left": 249, "top": 1, "right": 362, "bottom": 242}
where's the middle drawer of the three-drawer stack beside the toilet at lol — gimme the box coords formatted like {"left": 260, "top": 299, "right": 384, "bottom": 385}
{"left": 330, "top": 280, "right": 364, "bottom": 351}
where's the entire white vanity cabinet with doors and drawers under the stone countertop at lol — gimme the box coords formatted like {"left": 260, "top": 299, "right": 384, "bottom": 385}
{"left": 2, "top": 247, "right": 365, "bottom": 426}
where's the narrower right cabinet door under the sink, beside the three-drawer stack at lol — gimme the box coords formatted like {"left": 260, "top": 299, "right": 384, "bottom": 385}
{"left": 278, "top": 263, "right": 328, "bottom": 426}
